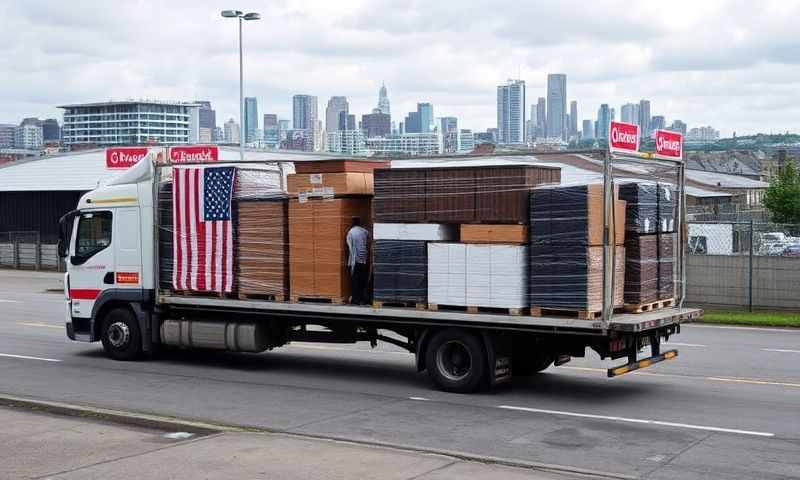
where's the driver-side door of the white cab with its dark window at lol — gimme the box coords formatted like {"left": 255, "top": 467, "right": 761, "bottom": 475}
{"left": 68, "top": 210, "right": 114, "bottom": 318}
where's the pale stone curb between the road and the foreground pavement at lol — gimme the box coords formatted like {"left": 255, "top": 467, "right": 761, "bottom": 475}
{"left": 0, "top": 394, "right": 639, "bottom": 480}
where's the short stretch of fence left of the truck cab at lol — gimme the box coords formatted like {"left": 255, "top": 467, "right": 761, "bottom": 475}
{"left": 0, "top": 231, "right": 64, "bottom": 272}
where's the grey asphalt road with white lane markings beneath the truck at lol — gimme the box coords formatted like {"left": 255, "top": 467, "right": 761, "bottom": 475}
{"left": 0, "top": 270, "right": 800, "bottom": 479}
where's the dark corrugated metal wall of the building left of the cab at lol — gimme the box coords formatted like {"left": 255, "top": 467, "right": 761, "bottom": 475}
{"left": 0, "top": 192, "right": 84, "bottom": 243}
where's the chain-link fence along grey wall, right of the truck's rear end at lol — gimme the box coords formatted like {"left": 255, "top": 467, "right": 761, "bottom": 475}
{"left": 686, "top": 222, "right": 800, "bottom": 310}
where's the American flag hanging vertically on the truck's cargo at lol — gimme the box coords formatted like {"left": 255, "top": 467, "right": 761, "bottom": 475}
{"left": 172, "top": 167, "right": 235, "bottom": 293}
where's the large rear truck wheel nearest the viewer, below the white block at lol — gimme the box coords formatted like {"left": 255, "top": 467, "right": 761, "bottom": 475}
{"left": 425, "top": 328, "right": 487, "bottom": 393}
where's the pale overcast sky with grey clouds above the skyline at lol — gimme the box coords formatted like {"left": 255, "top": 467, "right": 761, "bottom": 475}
{"left": 0, "top": 0, "right": 800, "bottom": 136}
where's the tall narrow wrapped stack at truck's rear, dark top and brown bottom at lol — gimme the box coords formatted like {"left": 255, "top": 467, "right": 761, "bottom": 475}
{"left": 619, "top": 183, "right": 659, "bottom": 305}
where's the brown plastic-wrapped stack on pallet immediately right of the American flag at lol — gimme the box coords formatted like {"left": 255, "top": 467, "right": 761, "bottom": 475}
{"left": 235, "top": 200, "right": 289, "bottom": 300}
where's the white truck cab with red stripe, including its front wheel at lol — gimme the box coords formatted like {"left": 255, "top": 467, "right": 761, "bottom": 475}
{"left": 59, "top": 157, "right": 154, "bottom": 354}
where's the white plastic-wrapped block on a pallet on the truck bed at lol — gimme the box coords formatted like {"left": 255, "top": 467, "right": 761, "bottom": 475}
{"left": 428, "top": 243, "right": 528, "bottom": 309}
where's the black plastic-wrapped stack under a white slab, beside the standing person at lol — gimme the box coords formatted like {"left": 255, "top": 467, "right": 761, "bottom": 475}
{"left": 372, "top": 240, "right": 428, "bottom": 304}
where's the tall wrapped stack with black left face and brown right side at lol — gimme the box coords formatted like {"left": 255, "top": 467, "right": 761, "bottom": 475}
{"left": 529, "top": 185, "right": 625, "bottom": 312}
